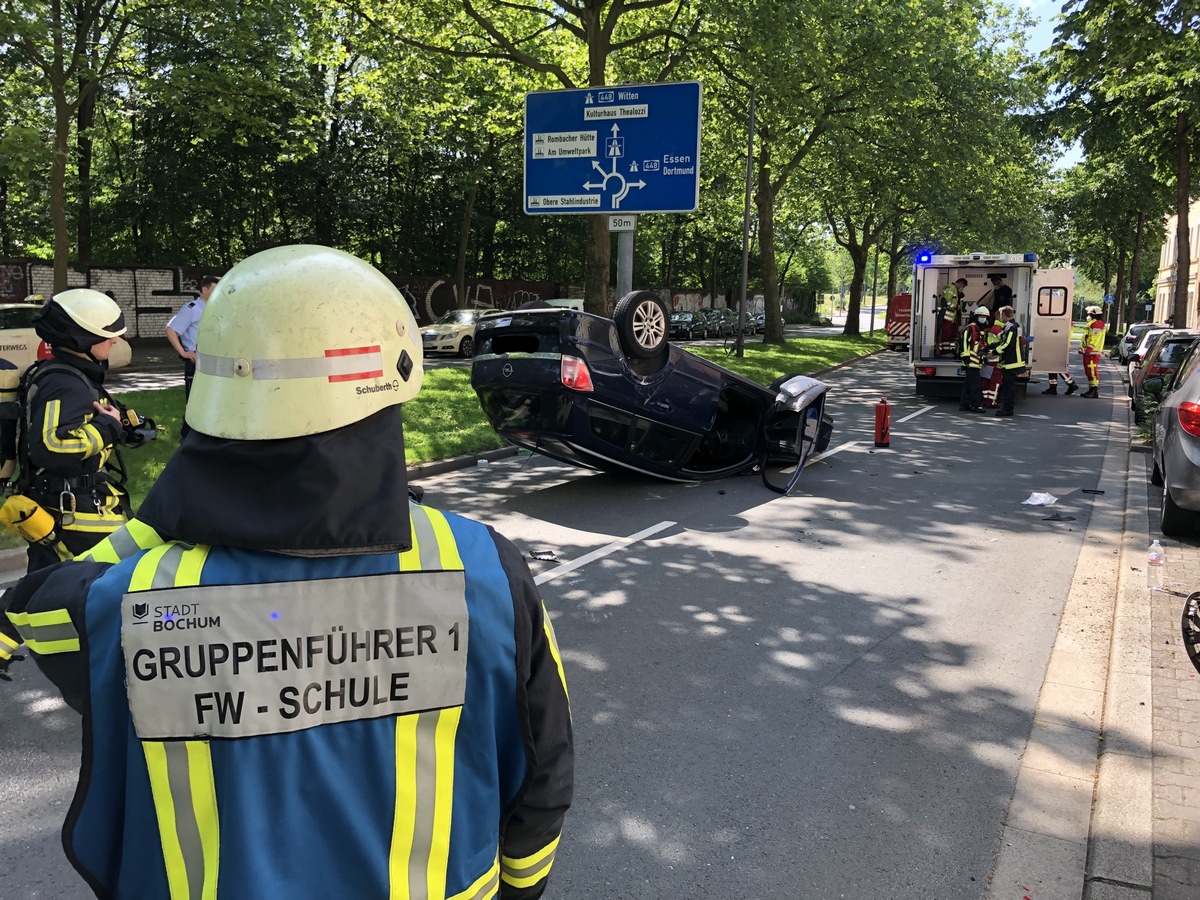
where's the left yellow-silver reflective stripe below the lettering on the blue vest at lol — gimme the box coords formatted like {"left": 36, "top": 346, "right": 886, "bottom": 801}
{"left": 142, "top": 740, "right": 221, "bottom": 900}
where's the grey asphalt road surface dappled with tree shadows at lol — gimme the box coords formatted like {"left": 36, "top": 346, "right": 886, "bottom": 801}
{"left": 0, "top": 353, "right": 1117, "bottom": 900}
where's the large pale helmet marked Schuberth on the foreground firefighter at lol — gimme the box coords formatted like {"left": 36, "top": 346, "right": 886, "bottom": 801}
{"left": 186, "top": 245, "right": 424, "bottom": 440}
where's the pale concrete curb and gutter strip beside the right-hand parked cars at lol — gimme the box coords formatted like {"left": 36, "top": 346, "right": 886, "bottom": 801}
{"left": 985, "top": 367, "right": 1153, "bottom": 900}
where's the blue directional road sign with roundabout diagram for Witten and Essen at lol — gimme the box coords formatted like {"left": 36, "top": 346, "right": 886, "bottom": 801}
{"left": 524, "top": 82, "right": 701, "bottom": 215}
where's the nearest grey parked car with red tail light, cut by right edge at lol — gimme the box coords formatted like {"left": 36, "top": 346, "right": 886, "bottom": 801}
{"left": 1142, "top": 342, "right": 1200, "bottom": 536}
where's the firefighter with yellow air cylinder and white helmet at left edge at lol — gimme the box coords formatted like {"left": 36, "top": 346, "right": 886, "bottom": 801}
{"left": 0, "top": 288, "right": 155, "bottom": 571}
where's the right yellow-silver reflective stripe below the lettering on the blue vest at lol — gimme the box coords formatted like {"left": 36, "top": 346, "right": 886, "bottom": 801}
{"left": 388, "top": 707, "right": 462, "bottom": 900}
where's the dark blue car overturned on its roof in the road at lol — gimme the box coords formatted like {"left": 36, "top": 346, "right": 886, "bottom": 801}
{"left": 470, "top": 290, "right": 833, "bottom": 493}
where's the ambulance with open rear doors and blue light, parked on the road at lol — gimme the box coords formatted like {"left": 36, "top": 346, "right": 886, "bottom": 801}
{"left": 908, "top": 253, "right": 1075, "bottom": 397}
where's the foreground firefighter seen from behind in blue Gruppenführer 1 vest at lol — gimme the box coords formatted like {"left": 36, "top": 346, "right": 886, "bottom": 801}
{"left": 4, "top": 246, "right": 574, "bottom": 900}
